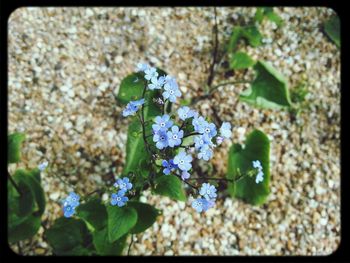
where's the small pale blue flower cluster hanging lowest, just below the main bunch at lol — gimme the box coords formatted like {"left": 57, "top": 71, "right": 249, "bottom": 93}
{"left": 192, "top": 183, "right": 217, "bottom": 213}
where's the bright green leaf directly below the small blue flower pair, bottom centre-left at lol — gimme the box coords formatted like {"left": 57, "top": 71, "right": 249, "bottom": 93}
{"left": 107, "top": 206, "right": 137, "bottom": 242}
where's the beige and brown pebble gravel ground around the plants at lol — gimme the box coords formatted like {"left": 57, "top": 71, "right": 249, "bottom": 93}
{"left": 8, "top": 8, "right": 340, "bottom": 255}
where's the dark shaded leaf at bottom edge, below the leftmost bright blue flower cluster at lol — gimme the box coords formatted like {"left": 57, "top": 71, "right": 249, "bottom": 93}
{"left": 45, "top": 217, "right": 92, "bottom": 255}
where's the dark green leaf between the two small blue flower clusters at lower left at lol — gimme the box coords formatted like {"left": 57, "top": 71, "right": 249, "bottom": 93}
{"left": 76, "top": 198, "right": 107, "bottom": 230}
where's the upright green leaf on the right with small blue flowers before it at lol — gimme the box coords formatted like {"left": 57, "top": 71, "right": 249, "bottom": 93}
{"left": 227, "top": 130, "right": 270, "bottom": 205}
